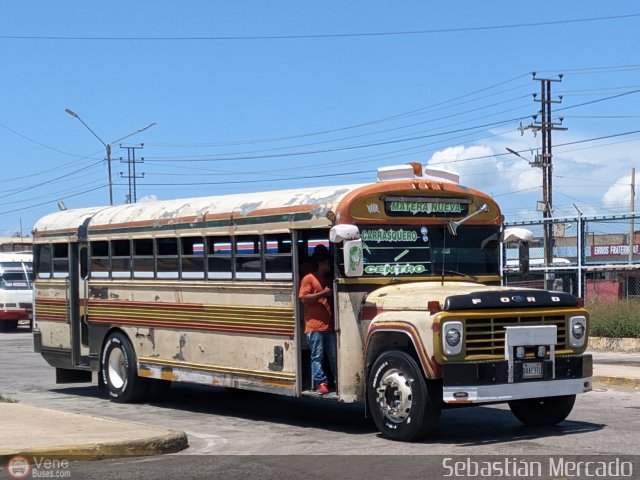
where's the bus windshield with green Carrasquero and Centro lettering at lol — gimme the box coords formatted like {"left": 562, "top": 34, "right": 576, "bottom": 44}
{"left": 360, "top": 225, "right": 499, "bottom": 277}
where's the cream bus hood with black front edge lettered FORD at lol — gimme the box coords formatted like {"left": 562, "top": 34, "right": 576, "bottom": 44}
{"left": 365, "top": 281, "right": 578, "bottom": 311}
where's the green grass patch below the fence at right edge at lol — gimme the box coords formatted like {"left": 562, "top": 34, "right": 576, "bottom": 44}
{"left": 587, "top": 300, "right": 640, "bottom": 338}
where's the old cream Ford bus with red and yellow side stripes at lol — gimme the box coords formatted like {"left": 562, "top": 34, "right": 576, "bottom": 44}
{"left": 34, "top": 164, "right": 592, "bottom": 441}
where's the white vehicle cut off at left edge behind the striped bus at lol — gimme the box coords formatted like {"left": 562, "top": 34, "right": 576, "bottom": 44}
{"left": 0, "top": 252, "right": 33, "bottom": 330}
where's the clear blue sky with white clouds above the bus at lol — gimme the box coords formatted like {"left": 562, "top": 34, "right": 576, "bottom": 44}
{"left": 0, "top": 0, "right": 640, "bottom": 236}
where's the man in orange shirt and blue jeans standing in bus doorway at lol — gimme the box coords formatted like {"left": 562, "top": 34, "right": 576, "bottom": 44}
{"left": 299, "top": 245, "right": 337, "bottom": 395}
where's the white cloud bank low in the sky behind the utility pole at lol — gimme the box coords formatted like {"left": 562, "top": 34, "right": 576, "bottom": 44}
{"left": 427, "top": 130, "right": 640, "bottom": 219}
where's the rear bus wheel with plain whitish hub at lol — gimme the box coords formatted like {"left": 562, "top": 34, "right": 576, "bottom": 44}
{"left": 100, "top": 332, "right": 149, "bottom": 403}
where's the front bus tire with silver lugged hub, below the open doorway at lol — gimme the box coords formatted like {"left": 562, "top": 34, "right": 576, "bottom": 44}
{"left": 367, "top": 350, "right": 442, "bottom": 442}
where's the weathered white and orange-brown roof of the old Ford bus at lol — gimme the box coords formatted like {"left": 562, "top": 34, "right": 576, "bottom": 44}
{"left": 34, "top": 177, "right": 502, "bottom": 242}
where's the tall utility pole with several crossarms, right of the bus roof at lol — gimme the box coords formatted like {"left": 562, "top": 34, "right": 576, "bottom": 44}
{"left": 521, "top": 72, "right": 567, "bottom": 289}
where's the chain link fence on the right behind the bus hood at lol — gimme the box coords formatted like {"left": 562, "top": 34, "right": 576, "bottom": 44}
{"left": 502, "top": 214, "right": 640, "bottom": 301}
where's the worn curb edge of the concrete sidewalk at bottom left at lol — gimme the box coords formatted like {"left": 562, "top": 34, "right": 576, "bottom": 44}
{"left": 0, "top": 430, "right": 189, "bottom": 463}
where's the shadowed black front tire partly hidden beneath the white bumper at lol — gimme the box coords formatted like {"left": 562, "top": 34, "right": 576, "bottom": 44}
{"left": 509, "top": 395, "right": 576, "bottom": 427}
